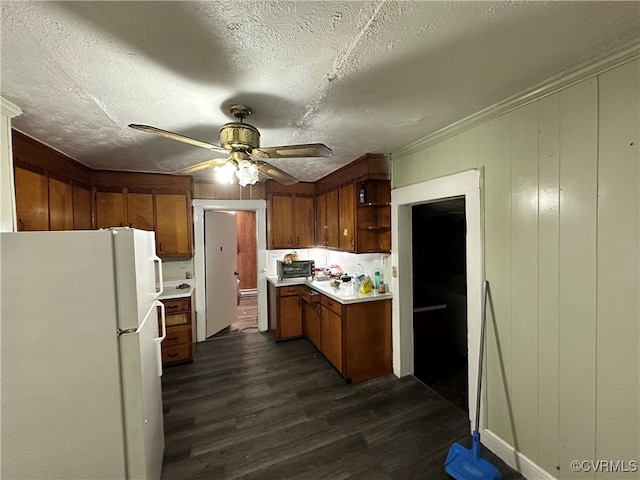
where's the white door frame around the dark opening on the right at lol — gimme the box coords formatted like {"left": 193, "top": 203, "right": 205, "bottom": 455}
{"left": 391, "top": 169, "right": 484, "bottom": 430}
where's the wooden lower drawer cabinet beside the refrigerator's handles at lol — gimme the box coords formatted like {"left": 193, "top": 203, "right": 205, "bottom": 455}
{"left": 162, "top": 296, "right": 193, "bottom": 365}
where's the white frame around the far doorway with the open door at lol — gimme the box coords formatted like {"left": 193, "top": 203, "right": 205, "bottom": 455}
{"left": 192, "top": 199, "right": 269, "bottom": 342}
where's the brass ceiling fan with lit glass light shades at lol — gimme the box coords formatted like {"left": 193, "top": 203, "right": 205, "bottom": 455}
{"left": 129, "top": 104, "right": 332, "bottom": 186}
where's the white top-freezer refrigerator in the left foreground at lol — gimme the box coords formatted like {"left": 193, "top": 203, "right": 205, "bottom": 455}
{"left": 0, "top": 228, "right": 166, "bottom": 480}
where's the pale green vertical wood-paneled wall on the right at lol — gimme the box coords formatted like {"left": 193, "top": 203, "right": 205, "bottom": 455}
{"left": 392, "top": 59, "right": 640, "bottom": 479}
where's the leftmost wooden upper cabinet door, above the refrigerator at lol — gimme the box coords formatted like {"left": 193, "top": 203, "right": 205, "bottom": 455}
{"left": 15, "top": 168, "right": 49, "bottom": 231}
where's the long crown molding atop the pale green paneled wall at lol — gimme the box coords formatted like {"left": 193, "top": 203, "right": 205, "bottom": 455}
{"left": 391, "top": 42, "right": 640, "bottom": 159}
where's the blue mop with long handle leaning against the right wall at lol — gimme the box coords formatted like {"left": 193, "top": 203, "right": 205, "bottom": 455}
{"left": 444, "top": 280, "right": 500, "bottom": 480}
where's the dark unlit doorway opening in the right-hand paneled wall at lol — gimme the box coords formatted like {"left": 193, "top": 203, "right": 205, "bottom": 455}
{"left": 412, "top": 197, "right": 469, "bottom": 412}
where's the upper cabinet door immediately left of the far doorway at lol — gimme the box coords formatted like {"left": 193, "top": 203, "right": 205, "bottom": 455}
{"left": 156, "top": 193, "right": 191, "bottom": 256}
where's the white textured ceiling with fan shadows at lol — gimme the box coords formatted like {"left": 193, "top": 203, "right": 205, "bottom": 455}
{"left": 1, "top": 0, "right": 640, "bottom": 181}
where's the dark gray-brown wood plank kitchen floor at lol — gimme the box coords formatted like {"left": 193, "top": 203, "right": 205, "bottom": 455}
{"left": 162, "top": 333, "right": 523, "bottom": 480}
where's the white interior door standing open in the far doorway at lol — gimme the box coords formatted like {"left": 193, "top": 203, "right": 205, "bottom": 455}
{"left": 204, "top": 210, "right": 238, "bottom": 337}
